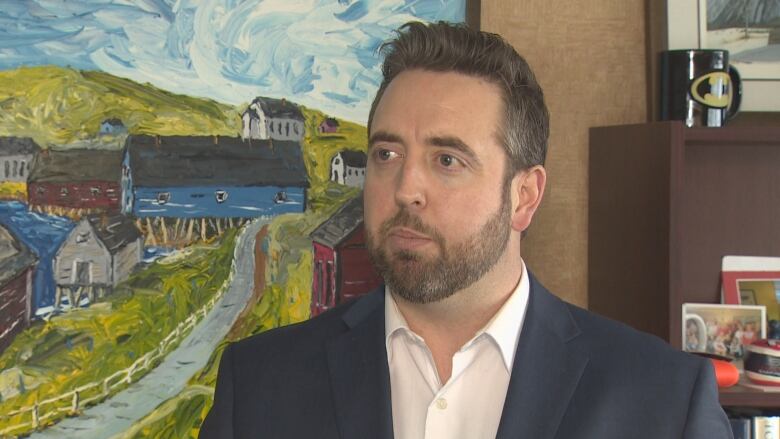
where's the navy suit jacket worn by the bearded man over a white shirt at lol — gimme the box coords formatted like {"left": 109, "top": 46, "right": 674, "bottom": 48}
{"left": 200, "top": 276, "right": 731, "bottom": 439}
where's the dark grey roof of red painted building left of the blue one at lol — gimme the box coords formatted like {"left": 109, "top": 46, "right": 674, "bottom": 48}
{"left": 29, "top": 149, "right": 122, "bottom": 183}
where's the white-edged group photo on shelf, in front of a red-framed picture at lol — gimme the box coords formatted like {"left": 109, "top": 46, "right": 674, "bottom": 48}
{"left": 681, "top": 303, "right": 766, "bottom": 360}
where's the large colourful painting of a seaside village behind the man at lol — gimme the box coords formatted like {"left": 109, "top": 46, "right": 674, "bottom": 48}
{"left": 0, "top": 0, "right": 466, "bottom": 438}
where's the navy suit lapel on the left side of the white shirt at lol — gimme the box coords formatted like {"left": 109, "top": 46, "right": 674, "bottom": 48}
{"left": 327, "top": 288, "right": 393, "bottom": 439}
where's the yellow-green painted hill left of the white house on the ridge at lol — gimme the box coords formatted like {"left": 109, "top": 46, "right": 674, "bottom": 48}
{"left": 0, "top": 66, "right": 241, "bottom": 147}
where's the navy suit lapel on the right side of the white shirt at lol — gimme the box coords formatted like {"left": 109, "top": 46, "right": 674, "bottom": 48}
{"left": 496, "top": 273, "right": 588, "bottom": 439}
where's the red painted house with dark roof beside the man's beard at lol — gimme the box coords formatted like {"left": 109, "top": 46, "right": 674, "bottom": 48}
{"left": 311, "top": 195, "right": 382, "bottom": 317}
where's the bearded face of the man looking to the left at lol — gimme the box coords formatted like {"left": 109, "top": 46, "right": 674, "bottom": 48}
{"left": 364, "top": 70, "right": 511, "bottom": 303}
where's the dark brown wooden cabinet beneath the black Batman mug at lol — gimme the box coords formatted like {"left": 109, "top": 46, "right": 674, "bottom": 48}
{"left": 588, "top": 122, "right": 780, "bottom": 407}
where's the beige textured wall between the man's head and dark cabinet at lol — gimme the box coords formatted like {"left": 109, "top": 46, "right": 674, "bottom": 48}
{"left": 481, "top": 0, "right": 647, "bottom": 306}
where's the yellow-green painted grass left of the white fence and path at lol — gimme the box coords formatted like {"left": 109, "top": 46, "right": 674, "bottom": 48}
{"left": 0, "top": 229, "right": 236, "bottom": 430}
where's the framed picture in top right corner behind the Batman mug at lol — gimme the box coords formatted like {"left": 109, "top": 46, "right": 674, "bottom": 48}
{"left": 667, "top": 0, "right": 780, "bottom": 111}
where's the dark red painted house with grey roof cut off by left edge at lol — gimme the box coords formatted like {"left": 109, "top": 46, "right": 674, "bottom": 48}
{"left": 0, "top": 225, "right": 36, "bottom": 352}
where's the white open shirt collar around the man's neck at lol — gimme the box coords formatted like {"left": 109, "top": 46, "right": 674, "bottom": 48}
{"left": 385, "top": 263, "right": 531, "bottom": 371}
